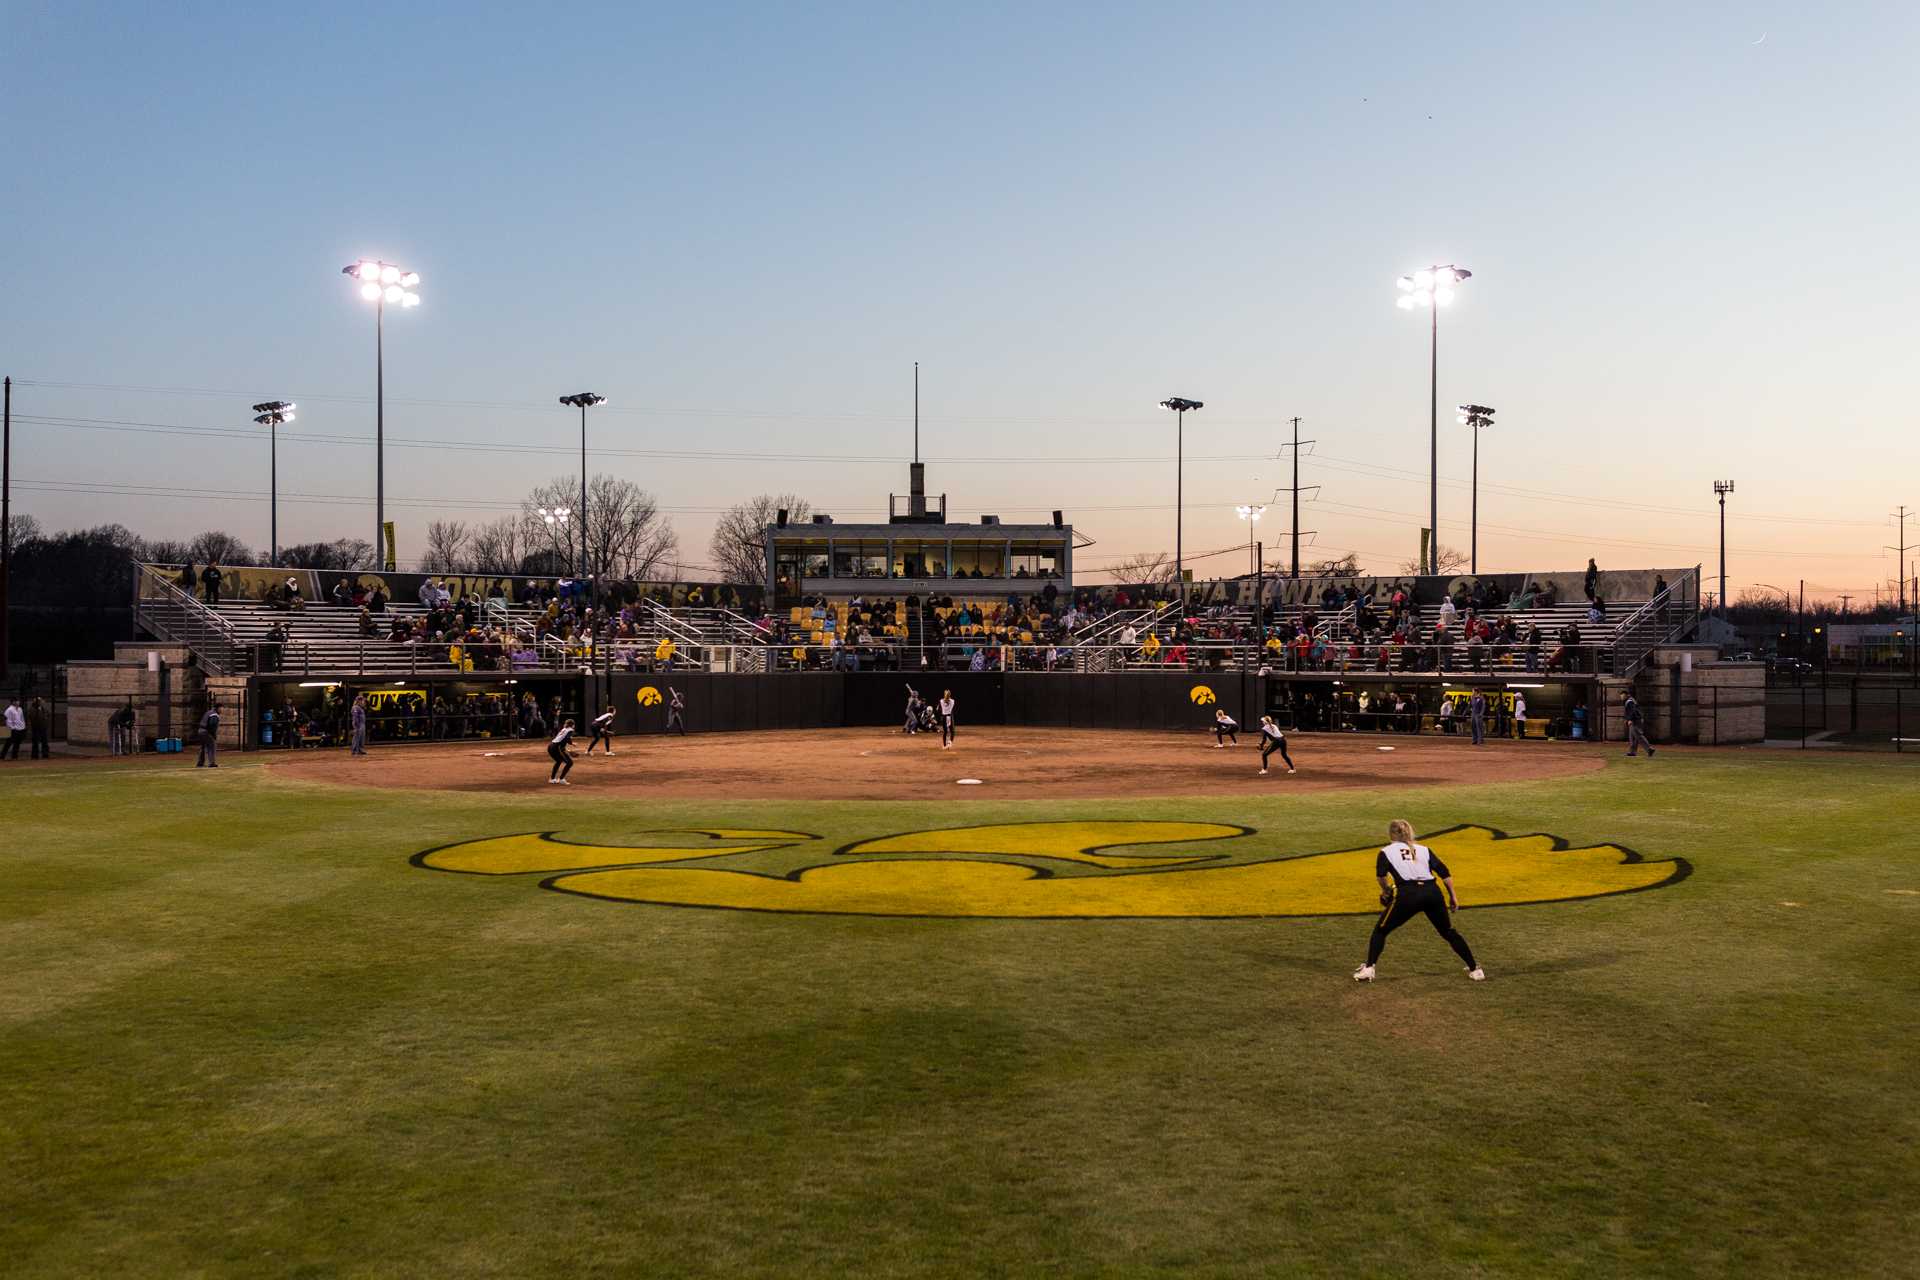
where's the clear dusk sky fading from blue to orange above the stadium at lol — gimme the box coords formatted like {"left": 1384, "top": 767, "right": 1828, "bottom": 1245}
{"left": 0, "top": 2, "right": 1920, "bottom": 604}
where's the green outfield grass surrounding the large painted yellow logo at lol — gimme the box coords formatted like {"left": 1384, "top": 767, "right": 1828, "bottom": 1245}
{"left": 0, "top": 750, "right": 1920, "bottom": 1276}
